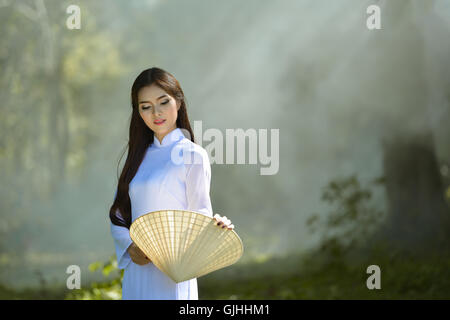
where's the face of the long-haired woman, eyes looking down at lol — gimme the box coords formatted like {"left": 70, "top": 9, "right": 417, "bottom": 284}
{"left": 138, "top": 84, "right": 180, "bottom": 142}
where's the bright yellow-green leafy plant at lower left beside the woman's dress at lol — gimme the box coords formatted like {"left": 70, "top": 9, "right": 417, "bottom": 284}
{"left": 65, "top": 255, "right": 123, "bottom": 300}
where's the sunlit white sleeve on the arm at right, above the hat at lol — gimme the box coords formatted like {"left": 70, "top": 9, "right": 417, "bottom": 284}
{"left": 186, "top": 149, "right": 213, "bottom": 217}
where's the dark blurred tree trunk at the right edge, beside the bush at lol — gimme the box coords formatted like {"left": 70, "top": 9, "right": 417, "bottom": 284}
{"left": 381, "top": 133, "right": 450, "bottom": 253}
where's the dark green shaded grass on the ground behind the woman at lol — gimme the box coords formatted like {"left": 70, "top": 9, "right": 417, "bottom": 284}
{"left": 0, "top": 246, "right": 450, "bottom": 300}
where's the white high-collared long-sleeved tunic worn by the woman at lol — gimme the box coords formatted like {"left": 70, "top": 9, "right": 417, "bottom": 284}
{"left": 110, "top": 128, "right": 213, "bottom": 300}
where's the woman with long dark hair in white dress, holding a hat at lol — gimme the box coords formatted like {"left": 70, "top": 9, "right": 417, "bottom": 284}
{"left": 109, "top": 68, "right": 233, "bottom": 300}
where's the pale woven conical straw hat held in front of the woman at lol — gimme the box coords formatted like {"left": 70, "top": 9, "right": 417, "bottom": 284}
{"left": 130, "top": 210, "right": 244, "bottom": 283}
